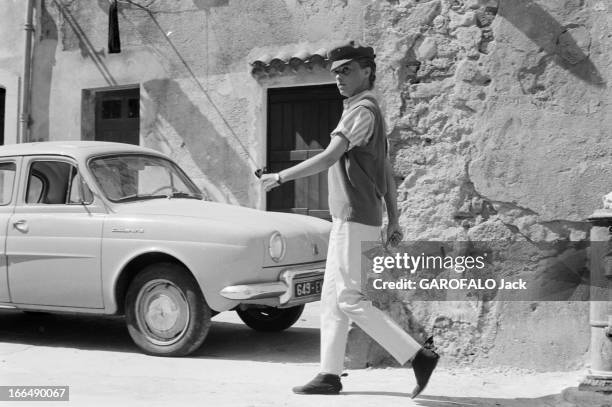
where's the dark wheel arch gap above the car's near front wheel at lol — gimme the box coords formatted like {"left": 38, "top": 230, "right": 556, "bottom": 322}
{"left": 114, "top": 251, "right": 198, "bottom": 315}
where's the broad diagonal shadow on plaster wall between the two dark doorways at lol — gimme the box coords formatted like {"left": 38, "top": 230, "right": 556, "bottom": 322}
{"left": 143, "top": 79, "right": 253, "bottom": 205}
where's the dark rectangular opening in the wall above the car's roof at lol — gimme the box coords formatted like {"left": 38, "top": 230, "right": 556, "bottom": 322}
{"left": 95, "top": 88, "right": 140, "bottom": 145}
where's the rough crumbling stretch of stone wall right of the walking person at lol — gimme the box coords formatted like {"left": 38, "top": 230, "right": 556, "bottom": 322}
{"left": 350, "top": 0, "right": 612, "bottom": 369}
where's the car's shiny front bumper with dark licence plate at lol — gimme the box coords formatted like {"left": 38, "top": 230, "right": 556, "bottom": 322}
{"left": 219, "top": 261, "right": 325, "bottom": 308}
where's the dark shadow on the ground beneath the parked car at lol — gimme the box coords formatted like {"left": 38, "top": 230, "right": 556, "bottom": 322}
{"left": 0, "top": 311, "right": 319, "bottom": 363}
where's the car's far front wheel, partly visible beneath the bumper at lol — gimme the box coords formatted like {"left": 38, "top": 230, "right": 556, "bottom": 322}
{"left": 236, "top": 304, "right": 304, "bottom": 332}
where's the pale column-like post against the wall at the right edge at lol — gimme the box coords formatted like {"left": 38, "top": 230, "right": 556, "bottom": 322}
{"left": 578, "top": 209, "right": 612, "bottom": 394}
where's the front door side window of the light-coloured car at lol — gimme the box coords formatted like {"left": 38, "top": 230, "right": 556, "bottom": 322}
{"left": 26, "top": 161, "right": 92, "bottom": 205}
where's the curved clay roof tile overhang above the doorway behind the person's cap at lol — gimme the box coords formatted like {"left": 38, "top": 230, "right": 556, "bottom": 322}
{"left": 250, "top": 42, "right": 340, "bottom": 76}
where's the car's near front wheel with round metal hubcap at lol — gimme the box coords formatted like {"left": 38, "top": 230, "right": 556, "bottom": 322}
{"left": 125, "top": 263, "right": 212, "bottom": 356}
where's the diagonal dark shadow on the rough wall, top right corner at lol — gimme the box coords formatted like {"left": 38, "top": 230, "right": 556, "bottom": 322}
{"left": 498, "top": 0, "right": 607, "bottom": 87}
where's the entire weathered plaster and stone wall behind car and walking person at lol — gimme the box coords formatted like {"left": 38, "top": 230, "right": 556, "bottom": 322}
{"left": 0, "top": 0, "right": 612, "bottom": 369}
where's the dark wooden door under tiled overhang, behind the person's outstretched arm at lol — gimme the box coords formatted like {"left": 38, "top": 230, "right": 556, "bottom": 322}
{"left": 267, "top": 85, "right": 342, "bottom": 219}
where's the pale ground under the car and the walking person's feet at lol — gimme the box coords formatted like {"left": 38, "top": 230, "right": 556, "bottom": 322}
{"left": 0, "top": 305, "right": 612, "bottom": 407}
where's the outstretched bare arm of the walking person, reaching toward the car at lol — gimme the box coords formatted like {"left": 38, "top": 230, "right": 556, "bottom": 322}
{"left": 261, "top": 135, "right": 348, "bottom": 191}
